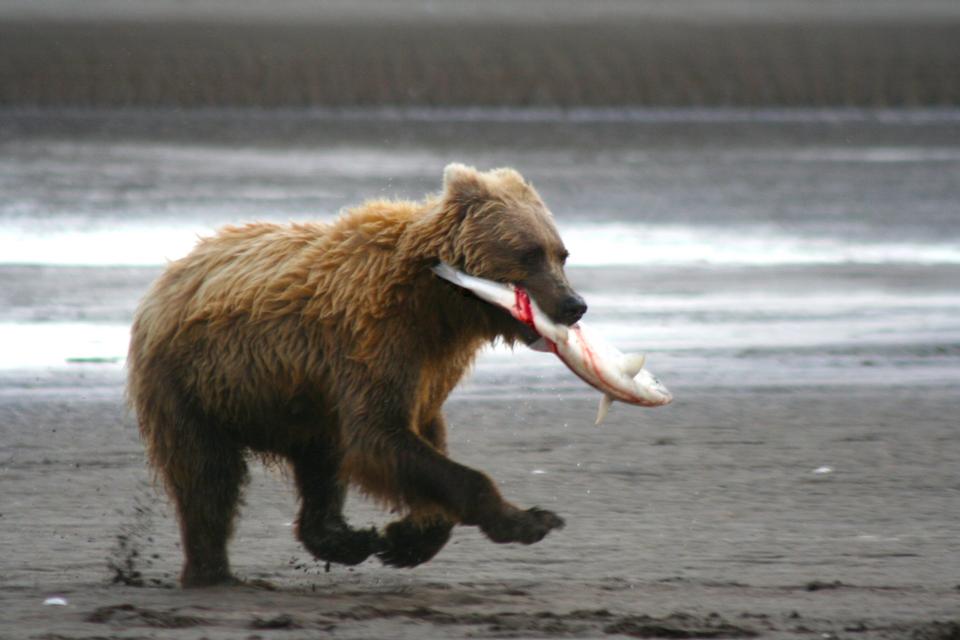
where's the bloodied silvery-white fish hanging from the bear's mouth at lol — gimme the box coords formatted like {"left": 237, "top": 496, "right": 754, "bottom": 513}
{"left": 433, "top": 262, "right": 673, "bottom": 425}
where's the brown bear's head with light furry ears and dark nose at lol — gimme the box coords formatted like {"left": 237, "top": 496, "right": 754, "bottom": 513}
{"left": 441, "top": 164, "right": 587, "bottom": 325}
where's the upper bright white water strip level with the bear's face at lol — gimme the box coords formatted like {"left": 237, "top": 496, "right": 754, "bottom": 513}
{"left": 0, "top": 218, "right": 960, "bottom": 267}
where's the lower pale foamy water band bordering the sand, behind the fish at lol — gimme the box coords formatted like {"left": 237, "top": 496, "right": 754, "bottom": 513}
{"left": 0, "top": 289, "right": 960, "bottom": 399}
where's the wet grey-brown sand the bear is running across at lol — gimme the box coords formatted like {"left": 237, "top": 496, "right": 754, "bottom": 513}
{"left": 0, "top": 380, "right": 960, "bottom": 639}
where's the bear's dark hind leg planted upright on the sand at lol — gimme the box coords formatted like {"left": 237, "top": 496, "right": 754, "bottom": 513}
{"left": 169, "top": 425, "right": 247, "bottom": 587}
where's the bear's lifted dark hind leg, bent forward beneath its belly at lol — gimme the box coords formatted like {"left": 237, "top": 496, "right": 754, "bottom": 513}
{"left": 290, "top": 445, "right": 384, "bottom": 565}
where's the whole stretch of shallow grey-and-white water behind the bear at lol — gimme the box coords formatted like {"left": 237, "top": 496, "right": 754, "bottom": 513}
{"left": 0, "top": 110, "right": 960, "bottom": 394}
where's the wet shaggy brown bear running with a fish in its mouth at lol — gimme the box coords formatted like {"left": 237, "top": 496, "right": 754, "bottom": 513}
{"left": 127, "top": 164, "right": 586, "bottom": 586}
